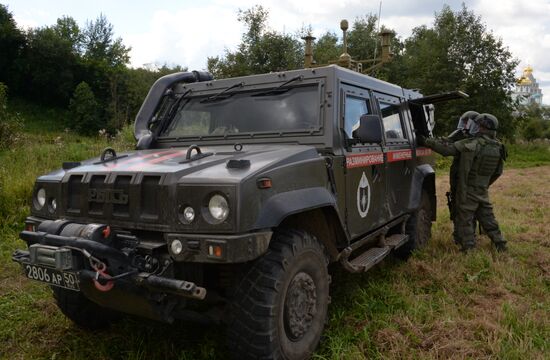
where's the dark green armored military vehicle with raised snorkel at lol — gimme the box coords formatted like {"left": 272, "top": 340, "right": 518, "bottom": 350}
{"left": 13, "top": 23, "right": 466, "bottom": 359}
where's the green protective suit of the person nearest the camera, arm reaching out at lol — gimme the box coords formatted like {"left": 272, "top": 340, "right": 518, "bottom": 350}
{"left": 426, "top": 133, "right": 506, "bottom": 249}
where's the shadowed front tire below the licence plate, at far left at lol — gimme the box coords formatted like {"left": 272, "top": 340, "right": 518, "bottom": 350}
{"left": 52, "top": 286, "right": 122, "bottom": 330}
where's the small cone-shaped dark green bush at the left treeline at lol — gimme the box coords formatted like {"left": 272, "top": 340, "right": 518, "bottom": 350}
{"left": 69, "top": 82, "right": 105, "bottom": 135}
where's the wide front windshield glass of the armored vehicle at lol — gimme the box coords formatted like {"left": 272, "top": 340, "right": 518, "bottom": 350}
{"left": 160, "top": 84, "right": 320, "bottom": 138}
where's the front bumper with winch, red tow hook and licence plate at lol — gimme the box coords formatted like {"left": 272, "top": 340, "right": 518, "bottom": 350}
{"left": 12, "top": 217, "right": 272, "bottom": 322}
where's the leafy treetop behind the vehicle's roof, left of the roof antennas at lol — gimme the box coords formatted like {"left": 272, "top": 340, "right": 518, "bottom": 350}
{"left": 208, "top": 6, "right": 303, "bottom": 78}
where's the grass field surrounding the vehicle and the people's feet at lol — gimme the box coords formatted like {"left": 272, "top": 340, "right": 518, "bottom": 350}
{"left": 0, "top": 116, "right": 550, "bottom": 359}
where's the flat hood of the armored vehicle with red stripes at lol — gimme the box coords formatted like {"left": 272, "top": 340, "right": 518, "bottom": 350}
{"left": 39, "top": 144, "right": 319, "bottom": 183}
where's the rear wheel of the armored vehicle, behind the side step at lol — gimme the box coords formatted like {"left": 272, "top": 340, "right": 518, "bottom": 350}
{"left": 395, "top": 191, "right": 433, "bottom": 260}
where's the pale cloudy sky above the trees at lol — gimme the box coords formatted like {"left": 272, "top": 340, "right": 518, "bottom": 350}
{"left": 5, "top": 0, "right": 550, "bottom": 105}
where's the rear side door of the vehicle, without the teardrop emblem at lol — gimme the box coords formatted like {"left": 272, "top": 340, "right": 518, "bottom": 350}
{"left": 374, "top": 92, "right": 414, "bottom": 219}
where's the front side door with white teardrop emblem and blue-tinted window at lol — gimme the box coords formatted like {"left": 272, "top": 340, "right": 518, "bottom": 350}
{"left": 340, "top": 86, "right": 388, "bottom": 239}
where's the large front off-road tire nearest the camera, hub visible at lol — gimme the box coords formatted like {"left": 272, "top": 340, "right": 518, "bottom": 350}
{"left": 227, "top": 230, "right": 330, "bottom": 359}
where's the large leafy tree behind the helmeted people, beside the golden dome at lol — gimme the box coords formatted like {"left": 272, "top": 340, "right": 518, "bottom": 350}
{"left": 389, "top": 5, "right": 518, "bottom": 137}
